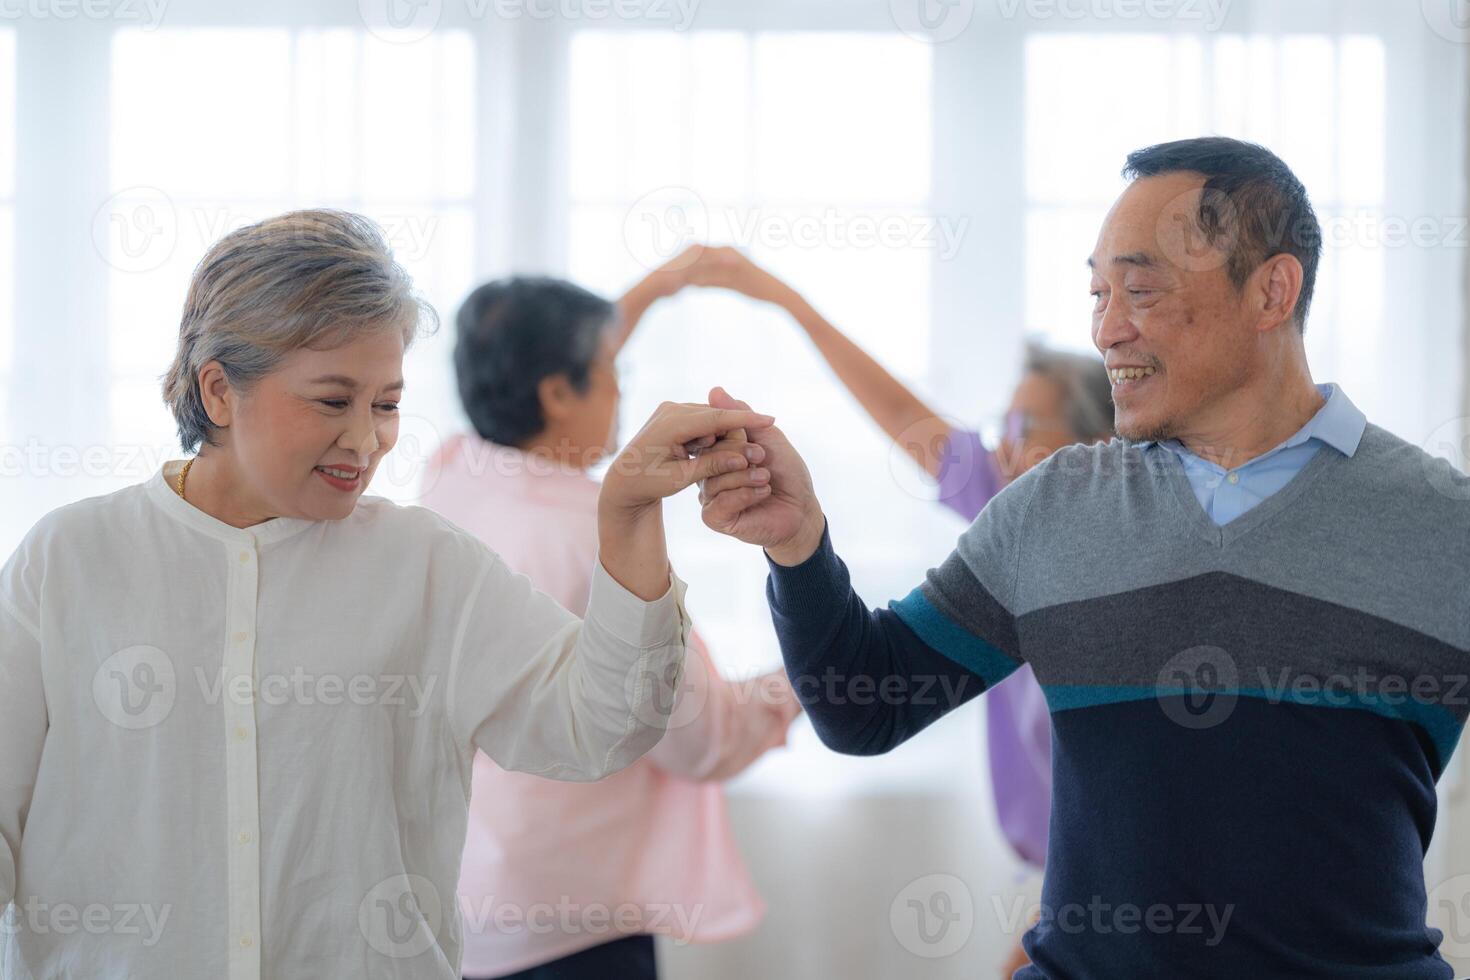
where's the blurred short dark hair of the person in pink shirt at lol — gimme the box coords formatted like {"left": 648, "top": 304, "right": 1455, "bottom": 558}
{"left": 454, "top": 276, "right": 617, "bottom": 447}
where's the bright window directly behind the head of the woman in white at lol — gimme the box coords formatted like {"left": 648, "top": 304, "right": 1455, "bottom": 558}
{"left": 107, "top": 29, "right": 475, "bottom": 500}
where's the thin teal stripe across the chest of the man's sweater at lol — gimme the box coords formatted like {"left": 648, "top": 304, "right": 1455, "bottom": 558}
{"left": 1041, "top": 685, "right": 1464, "bottom": 765}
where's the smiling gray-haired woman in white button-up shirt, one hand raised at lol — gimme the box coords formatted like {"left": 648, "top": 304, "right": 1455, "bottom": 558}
{"left": 0, "top": 212, "right": 770, "bottom": 980}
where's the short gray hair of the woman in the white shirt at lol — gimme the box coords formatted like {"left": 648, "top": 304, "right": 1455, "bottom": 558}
{"left": 162, "top": 209, "right": 438, "bottom": 453}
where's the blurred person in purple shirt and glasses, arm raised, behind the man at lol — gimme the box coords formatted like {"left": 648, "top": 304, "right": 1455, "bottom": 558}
{"left": 689, "top": 247, "right": 1113, "bottom": 977}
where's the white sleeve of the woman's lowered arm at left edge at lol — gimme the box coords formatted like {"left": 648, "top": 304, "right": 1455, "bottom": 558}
{"left": 0, "top": 542, "right": 49, "bottom": 915}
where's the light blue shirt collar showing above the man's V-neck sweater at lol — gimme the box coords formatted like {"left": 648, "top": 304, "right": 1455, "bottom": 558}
{"left": 1138, "top": 385, "right": 1369, "bottom": 525}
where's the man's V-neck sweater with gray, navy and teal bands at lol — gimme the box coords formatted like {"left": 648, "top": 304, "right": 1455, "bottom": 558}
{"left": 767, "top": 425, "right": 1470, "bottom": 980}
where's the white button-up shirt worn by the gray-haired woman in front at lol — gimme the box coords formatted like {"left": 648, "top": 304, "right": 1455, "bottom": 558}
{"left": 0, "top": 461, "right": 689, "bottom": 980}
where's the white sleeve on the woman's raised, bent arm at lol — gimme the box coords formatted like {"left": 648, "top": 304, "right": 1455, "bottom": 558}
{"left": 445, "top": 548, "right": 689, "bottom": 780}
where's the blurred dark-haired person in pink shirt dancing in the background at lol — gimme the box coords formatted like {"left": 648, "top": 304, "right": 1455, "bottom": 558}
{"left": 422, "top": 254, "right": 800, "bottom": 980}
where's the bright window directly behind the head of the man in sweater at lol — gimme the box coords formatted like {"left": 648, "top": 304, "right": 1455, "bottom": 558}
{"left": 1026, "top": 34, "right": 1395, "bottom": 417}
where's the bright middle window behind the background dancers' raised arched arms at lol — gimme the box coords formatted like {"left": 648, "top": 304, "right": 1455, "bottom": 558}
{"left": 567, "top": 31, "right": 979, "bottom": 795}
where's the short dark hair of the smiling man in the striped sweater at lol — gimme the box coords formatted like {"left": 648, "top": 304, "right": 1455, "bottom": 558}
{"left": 1123, "top": 137, "right": 1322, "bottom": 331}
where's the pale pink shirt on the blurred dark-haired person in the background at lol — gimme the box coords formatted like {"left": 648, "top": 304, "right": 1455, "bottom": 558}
{"left": 422, "top": 433, "right": 800, "bottom": 977}
